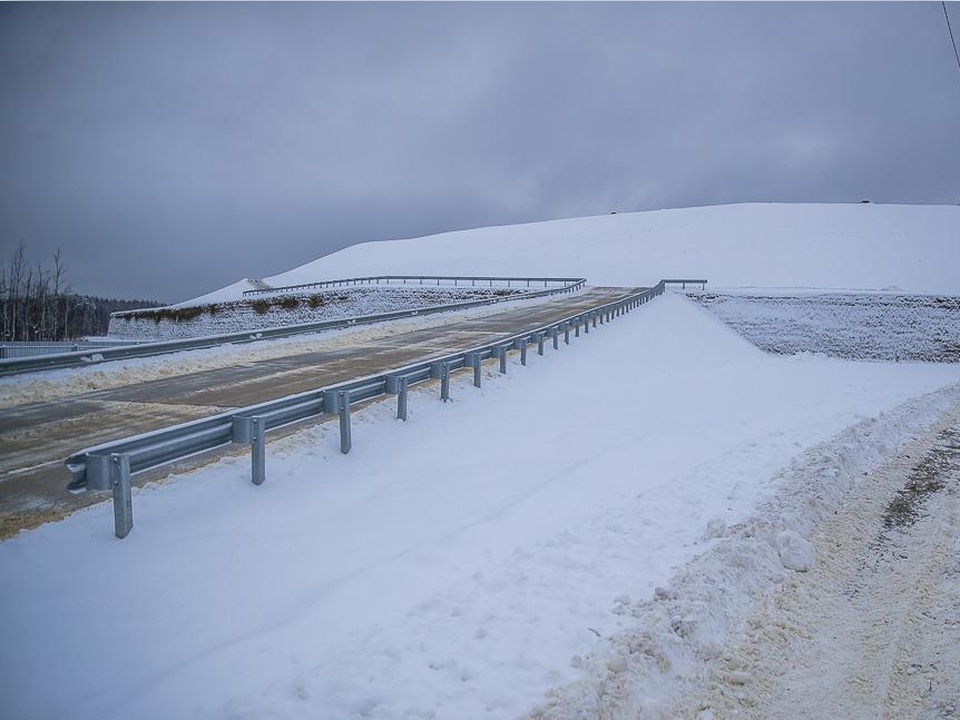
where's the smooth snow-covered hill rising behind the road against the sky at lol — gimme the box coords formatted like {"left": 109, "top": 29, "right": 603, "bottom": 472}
{"left": 186, "top": 203, "right": 960, "bottom": 306}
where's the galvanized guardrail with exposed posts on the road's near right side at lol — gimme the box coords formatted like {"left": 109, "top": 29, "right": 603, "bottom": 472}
{"left": 65, "top": 280, "right": 706, "bottom": 538}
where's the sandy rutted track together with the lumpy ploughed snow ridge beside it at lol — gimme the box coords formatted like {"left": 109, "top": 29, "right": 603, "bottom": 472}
{"left": 523, "top": 385, "right": 960, "bottom": 720}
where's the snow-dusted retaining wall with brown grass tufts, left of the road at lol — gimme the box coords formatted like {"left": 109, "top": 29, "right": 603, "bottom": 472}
{"left": 108, "top": 285, "right": 537, "bottom": 342}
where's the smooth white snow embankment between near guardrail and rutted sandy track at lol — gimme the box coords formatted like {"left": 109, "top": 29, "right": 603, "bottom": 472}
{"left": 0, "top": 295, "right": 960, "bottom": 719}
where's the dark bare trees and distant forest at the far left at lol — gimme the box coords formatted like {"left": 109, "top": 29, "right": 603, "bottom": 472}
{"left": 0, "top": 244, "right": 162, "bottom": 341}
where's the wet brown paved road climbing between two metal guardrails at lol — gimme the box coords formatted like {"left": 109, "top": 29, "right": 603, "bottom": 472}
{"left": 0, "top": 287, "right": 646, "bottom": 539}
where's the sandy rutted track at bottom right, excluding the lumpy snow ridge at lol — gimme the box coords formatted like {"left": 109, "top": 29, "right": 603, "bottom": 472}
{"left": 681, "top": 407, "right": 960, "bottom": 720}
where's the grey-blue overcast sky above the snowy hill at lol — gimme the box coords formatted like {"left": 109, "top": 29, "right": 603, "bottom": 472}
{"left": 0, "top": 2, "right": 960, "bottom": 302}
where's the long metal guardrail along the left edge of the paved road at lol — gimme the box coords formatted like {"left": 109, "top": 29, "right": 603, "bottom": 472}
{"left": 0, "top": 278, "right": 587, "bottom": 377}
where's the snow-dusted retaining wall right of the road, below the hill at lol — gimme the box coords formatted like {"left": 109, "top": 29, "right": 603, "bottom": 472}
{"left": 690, "top": 292, "right": 960, "bottom": 362}
